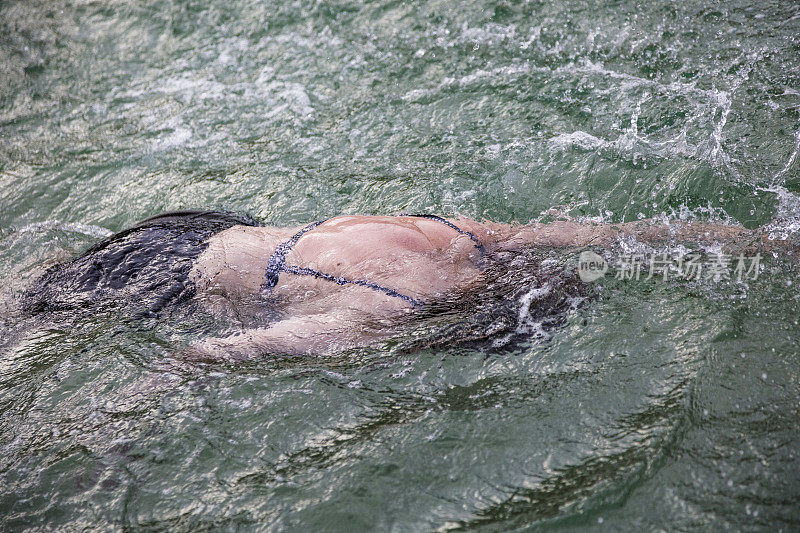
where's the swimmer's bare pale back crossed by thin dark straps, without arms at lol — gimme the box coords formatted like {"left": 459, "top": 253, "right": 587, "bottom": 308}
{"left": 191, "top": 216, "right": 488, "bottom": 316}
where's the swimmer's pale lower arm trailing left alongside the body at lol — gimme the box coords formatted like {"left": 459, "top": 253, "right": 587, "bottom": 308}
{"left": 185, "top": 314, "right": 382, "bottom": 362}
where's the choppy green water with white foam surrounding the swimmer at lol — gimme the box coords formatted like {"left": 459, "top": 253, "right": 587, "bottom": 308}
{"left": 0, "top": 0, "right": 800, "bottom": 531}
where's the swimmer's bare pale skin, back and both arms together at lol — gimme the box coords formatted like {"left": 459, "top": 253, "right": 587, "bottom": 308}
{"left": 187, "top": 216, "right": 775, "bottom": 360}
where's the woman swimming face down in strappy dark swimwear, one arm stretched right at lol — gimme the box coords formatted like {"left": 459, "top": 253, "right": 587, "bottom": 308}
{"left": 23, "top": 211, "right": 788, "bottom": 359}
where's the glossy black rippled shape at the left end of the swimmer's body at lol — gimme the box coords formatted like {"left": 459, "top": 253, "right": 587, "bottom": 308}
{"left": 21, "top": 211, "right": 263, "bottom": 315}
